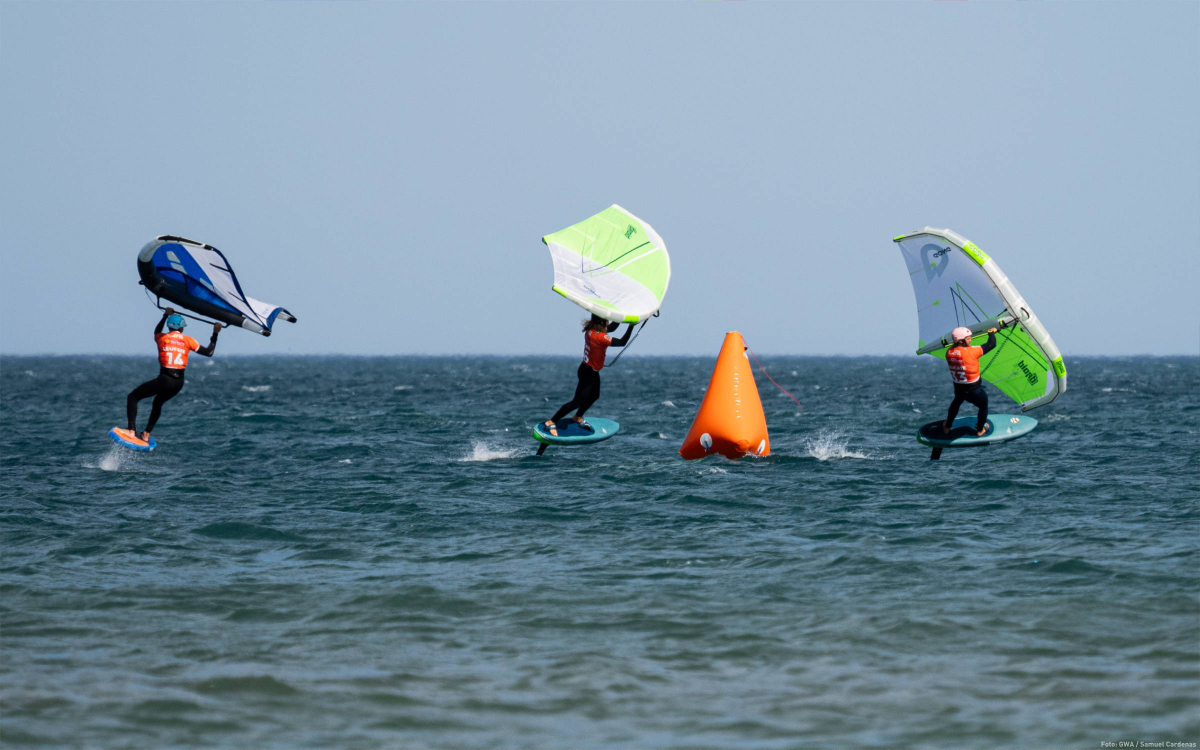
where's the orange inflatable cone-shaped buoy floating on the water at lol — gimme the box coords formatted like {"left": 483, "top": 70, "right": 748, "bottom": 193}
{"left": 679, "top": 331, "right": 770, "bottom": 461}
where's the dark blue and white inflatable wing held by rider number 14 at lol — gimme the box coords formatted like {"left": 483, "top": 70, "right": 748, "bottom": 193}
{"left": 138, "top": 234, "right": 296, "bottom": 336}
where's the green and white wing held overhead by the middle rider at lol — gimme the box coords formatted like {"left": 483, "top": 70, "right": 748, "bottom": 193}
{"left": 541, "top": 204, "right": 671, "bottom": 323}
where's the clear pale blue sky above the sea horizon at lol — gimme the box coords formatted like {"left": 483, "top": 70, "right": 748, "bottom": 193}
{"left": 0, "top": 2, "right": 1200, "bottom": 358}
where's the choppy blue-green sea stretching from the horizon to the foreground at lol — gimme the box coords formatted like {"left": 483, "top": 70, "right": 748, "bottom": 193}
{"left": 0, "top": 347, "right": 1200, "bottom": 748}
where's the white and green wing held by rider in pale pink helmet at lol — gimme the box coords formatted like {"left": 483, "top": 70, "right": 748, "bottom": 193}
{"left": 893, "top": 227, "right": 1067, "bottom": 412}
